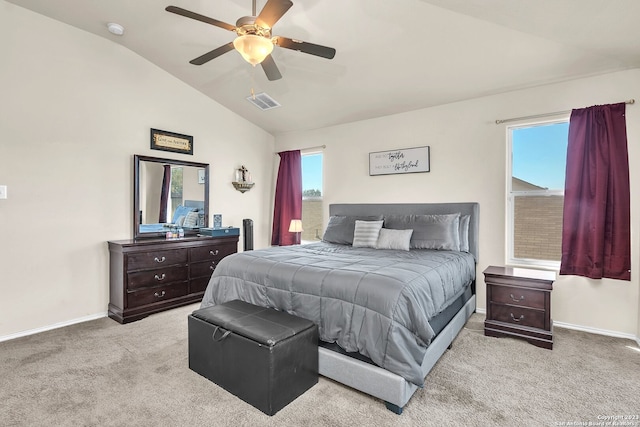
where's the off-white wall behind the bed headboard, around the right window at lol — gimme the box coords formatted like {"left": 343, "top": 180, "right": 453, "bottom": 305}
{"left": 276, "top": 69, "right": 640, "bottom": 337}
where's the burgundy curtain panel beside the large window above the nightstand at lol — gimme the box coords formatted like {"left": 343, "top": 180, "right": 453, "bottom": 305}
{"left": 560, "top": 103, "right": 631, "bottom": 280}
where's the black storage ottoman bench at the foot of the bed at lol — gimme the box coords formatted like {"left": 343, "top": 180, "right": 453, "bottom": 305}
{"left": 188, "top": 300, "right": 318, "bottom": 415}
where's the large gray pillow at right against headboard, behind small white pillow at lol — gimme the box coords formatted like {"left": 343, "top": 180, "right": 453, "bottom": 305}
{"left": 384, "top": 213, "right": 460, "bottom": 251}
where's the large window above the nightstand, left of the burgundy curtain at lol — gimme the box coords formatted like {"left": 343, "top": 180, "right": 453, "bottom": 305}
{"left": 507, "top": 118, "right": 569, "bottom": 267}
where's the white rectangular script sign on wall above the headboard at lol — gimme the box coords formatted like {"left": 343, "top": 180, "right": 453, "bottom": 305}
{"left": 369, "top": 146, "right": 429, "bottom": 175}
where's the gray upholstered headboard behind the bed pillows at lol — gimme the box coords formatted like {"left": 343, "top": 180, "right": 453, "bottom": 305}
{"left": 329, "top": 202, "right": 480, "bottom": 262}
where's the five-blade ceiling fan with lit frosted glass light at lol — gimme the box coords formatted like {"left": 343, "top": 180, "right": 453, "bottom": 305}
{"left": 165, "top": 0, "right": 336, "bottom": 80}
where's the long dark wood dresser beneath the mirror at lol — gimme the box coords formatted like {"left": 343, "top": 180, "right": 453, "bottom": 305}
{"left": 108, "top": 236, "right": 238, "bottom": 323}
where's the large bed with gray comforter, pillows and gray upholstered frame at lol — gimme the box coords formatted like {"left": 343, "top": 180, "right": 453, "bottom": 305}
{"left": 201, "top": 203, "right": 479, "bottom": 414}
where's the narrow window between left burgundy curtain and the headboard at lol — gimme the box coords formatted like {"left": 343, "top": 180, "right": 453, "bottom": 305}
{"left": 301, "top": 152, "right": 324, "bottom": 242}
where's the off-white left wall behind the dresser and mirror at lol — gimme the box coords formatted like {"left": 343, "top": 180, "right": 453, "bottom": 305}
{"left": 0, "top": 0, "right": 274, "bottom": 338}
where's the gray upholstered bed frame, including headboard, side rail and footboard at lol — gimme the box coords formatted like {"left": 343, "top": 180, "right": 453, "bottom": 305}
{"left": 318, "top": 202, "right": 480, "bottom": 414}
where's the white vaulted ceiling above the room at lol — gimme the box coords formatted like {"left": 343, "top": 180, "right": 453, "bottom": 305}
{"left": 7, "top": 0, "right": 640, "bottom": 134}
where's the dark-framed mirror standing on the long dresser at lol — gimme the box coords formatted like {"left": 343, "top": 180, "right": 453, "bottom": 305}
{"left": 133, "top": 154, "right": 209, "bottom": 239}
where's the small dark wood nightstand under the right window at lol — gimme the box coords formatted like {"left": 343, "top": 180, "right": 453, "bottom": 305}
{"left": 484, "top": 266, "right": 556, "bottom": 350}
